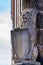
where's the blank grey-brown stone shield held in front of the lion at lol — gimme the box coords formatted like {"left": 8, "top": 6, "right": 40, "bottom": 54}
{"left": 11, "top": 29, "right": 29, "bottom": 58}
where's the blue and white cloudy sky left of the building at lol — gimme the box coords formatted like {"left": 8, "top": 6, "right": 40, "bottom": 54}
{"left": 0, "top": 0, "right": 12, "bottom": 65}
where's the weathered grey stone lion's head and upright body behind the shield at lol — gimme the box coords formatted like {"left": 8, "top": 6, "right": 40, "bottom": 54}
{"left": 22, "top": 9, "right": 37, "bottom": 58}
